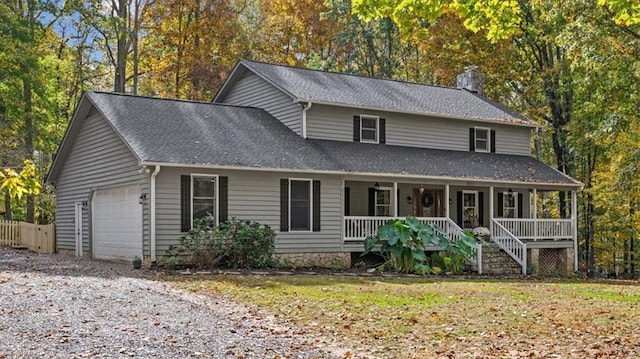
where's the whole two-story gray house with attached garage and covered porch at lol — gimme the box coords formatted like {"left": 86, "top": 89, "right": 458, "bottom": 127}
{"left": 48, "top": 60, "right": 581, "bottom": 270}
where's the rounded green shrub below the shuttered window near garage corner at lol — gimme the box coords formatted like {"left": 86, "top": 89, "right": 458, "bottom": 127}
{"left": 165, "top": 217, "right": 276, "bottom": 268}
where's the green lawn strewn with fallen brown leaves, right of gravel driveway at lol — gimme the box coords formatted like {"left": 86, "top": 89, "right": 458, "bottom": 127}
{"left": 169, "top": 275, "right": 640, "bottom": 358}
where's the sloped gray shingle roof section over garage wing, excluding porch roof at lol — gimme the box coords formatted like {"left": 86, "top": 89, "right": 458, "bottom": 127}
{"left": 88, "top": 92, "right": 333, "bottom": 170}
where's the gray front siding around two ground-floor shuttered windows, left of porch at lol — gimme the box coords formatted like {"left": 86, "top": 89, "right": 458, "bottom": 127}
{"left": 156, "top": 167, "right": 342, "bottom": 256}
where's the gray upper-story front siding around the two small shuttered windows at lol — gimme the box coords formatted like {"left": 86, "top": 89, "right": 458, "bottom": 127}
{"left": 307, "top": 105, "right": 531, "bottom": 156}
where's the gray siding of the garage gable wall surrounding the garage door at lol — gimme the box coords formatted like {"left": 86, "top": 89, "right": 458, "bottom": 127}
{"left": 55, "top": 112, "right": 149, "bottom": 255}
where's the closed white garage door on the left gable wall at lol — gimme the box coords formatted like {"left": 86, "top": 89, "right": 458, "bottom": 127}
{"left": 92, "top": 185, "right": 142, "bottom": 260}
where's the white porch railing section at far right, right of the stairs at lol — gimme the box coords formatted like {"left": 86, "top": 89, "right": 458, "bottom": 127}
{"left": 494, "top": 218, "right": 573, "bottom": 241}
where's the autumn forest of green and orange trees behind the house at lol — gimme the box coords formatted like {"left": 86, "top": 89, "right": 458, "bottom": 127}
{"left": 0, "top": 0, "right": 640, "bottom": 276}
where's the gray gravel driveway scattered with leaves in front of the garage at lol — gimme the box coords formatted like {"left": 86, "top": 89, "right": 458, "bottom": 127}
{"left": 0, "top": 247, "right": 349, "bottom": 359}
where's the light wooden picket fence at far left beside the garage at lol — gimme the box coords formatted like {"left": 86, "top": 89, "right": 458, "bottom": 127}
{"left": 0, "top": 221, "right": 56, "bottom": 253}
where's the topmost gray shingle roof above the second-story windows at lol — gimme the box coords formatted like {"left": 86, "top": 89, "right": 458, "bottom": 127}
{"left": 238, "top": 60, "right": 537, "bottom": 126}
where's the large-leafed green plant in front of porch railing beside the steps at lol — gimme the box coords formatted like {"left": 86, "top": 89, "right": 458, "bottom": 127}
{"left": 363, "top": 216, "right": 476, "bottom": 274}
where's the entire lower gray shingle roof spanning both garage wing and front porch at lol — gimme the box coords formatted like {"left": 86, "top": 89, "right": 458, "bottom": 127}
{"left": 82, "top": 92, "right": 578, "bottom": 185}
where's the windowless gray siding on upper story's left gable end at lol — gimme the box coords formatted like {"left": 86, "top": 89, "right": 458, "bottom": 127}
{"left": 221, "top": 72, "right": 302, "bottom": 135}
